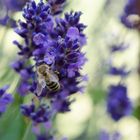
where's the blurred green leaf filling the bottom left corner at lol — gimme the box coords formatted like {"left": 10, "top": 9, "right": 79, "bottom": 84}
{"left": 0, "top": 94, "right": 26, "bottom": 140}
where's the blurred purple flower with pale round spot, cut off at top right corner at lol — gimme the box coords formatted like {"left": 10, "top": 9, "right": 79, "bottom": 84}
{"left": 121, "top": 0, "right": 140, "bottom": 29}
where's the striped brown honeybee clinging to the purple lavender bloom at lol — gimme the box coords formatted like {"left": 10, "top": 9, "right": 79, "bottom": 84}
{"left": 37, "top": 64, "right": 60, "bottom": 95}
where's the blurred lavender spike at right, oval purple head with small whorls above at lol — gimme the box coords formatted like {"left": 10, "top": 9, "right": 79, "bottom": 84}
{"left": 107, "top": 40, "right": 132, "bottom": 121}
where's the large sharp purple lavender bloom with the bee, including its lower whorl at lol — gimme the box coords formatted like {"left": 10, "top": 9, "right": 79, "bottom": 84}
{"left": 12, "top": 0, "right": 86, "bottom": 140}
